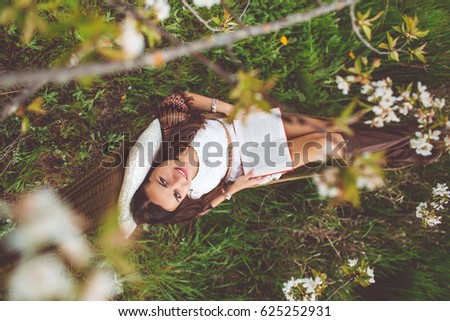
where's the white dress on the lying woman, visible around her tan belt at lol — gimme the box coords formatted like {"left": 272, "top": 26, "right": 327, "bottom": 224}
{"left": 188, "top": 119, "right": 282, "bottom": 199}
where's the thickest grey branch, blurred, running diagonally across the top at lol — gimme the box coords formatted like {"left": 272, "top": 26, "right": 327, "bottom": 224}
{"left": 0, "top": 0, "right": 358, "bottom": 87}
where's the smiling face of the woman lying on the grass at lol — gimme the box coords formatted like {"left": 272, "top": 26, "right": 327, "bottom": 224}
{"left": 144, "top": 152, "right": 196, "bottom": 211}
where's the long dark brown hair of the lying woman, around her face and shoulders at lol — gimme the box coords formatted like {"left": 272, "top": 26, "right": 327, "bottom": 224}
{"left": 131, "top": 94, "right": 227, "bottom": 224}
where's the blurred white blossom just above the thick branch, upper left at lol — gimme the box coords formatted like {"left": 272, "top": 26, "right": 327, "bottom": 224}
{"left": 117, "top": 17, "right": 145, "bottom": 59}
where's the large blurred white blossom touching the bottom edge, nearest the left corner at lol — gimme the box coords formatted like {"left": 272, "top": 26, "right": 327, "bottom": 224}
{"left": 9, "top": 255, "right": 75, "bottom": 301}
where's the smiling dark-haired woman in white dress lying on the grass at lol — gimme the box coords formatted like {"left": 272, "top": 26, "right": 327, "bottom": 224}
{"left": 61, "top": 93, "right": 439, "bottom": 237}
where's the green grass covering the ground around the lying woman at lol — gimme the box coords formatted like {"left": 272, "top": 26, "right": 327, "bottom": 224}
{"left": 0, "top": 0, "right": 450, "bottom": 300}
